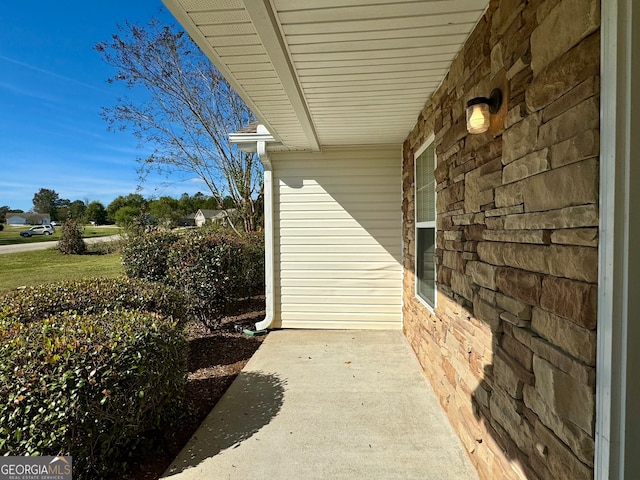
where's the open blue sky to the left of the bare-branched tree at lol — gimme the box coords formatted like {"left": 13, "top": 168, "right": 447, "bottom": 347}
{"left": 0, "top": 0, "right": 206, "bottom": 211}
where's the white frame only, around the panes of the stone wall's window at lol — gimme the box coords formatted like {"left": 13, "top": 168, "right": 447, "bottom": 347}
{"left": 413, "top": 134, "right": 438, "bottom": 313}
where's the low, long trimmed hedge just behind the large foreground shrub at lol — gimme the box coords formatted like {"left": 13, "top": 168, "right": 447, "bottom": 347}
{"left": 0, "top": 277, "right": 187, "bottom": 322}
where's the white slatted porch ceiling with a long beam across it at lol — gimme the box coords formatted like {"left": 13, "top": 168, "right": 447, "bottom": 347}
{"left": 163, "top": 0, "right": 489, "bottom": 150}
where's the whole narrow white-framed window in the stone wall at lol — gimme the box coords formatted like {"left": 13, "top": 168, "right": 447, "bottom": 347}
{"left": 415, "top": 143, "right": 436, "bottom": 308}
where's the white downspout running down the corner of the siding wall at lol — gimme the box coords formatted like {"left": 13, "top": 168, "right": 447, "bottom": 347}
{"left": 256, "top": 140, "right": 275, "bottom": 331}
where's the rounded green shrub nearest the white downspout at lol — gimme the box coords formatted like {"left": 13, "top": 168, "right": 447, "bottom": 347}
{"left": 167, "top": 231, "right": 242, "bottom": 328}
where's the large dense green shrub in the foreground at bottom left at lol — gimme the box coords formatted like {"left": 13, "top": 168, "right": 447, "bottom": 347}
{"left": 0, "top": 310, "right": 187, "bottom": 479}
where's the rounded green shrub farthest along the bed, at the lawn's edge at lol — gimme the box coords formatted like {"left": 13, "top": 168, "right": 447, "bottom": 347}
{"left": 122, "top": 232, "right": 179, "bottom": 281}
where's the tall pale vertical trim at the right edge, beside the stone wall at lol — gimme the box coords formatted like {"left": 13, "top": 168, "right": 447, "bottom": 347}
{"left": 594, "top": 0, "right": 640, "bottom": 480}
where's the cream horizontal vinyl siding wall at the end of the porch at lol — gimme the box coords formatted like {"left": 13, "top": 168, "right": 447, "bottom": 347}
{"left": 271, "top": 147, "right": 402, "bottom": 329}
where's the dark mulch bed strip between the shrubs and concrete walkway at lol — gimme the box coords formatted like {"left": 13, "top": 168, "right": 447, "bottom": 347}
{"left": 124, "top": 297, "right": 265, "bottom": 480}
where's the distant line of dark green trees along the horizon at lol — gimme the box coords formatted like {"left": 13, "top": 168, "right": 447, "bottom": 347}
{"left": 0, "top": 188, "right": 240, "bottom": 227}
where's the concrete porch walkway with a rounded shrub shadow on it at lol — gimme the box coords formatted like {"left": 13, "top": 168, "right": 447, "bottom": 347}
{"left": 162, "top": 330, "right": 477, "bottom": 480}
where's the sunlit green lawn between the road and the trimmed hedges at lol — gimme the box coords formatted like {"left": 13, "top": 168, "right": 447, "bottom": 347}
{"left": 0, "top": 249, "right": 124, "bottom": 294}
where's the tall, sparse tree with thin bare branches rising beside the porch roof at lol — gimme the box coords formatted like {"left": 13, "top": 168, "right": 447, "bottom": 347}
{"left": 95, "top": 19, "right": 262, "bottom": 231}
